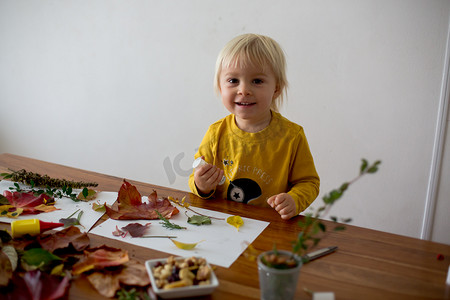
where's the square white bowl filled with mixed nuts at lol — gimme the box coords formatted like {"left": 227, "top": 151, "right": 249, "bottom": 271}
{"left": 145, "top": 256, "right": 219, "bottom": 299}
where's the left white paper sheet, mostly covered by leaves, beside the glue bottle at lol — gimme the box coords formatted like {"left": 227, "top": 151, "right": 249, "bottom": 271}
{"left": 0, "top": 180, "right": 117, "bottom": 232}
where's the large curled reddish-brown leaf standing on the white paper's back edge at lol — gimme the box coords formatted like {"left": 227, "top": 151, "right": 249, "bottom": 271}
{"left": 106, "top": 180, "right": 179, "bottom": 220}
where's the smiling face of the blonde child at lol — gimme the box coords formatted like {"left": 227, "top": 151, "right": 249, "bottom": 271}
{"left": 220, "top": 63, "right": 280, "bottom": 132}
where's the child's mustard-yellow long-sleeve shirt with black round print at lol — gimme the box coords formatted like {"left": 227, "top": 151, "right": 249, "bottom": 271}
{"left": 189, "top": 112, "right": 320, "bottom": 213}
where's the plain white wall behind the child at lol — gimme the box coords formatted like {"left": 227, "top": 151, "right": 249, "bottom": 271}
{"left": 0, "top": 0, "right": 450, "bottom": 244}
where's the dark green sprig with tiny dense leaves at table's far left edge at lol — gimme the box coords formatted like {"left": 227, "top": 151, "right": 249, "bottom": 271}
{"left": 0, "top": 169, "right": 98, "bottom": 202}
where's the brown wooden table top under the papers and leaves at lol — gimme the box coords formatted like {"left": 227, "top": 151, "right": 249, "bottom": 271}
{"left": 0, "top": 154, "right": 450, "bottom": 300}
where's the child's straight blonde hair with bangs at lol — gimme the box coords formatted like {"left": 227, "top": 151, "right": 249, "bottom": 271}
{"left": 214, "top": 33, "right": 288, "bottom": 111}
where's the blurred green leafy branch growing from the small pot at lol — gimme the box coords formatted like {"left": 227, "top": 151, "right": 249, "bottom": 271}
{"left": 292, "top": 159, "right": 381, "bottom": 256}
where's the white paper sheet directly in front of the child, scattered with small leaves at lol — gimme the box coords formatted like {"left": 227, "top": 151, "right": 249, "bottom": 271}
{"left": 90, "top": 207, "right": 269, "bottom": 268}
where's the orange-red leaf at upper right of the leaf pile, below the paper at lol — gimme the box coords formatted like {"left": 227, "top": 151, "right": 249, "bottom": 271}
{"left": 72, "top": 245, "right": 129, "bottom": 275}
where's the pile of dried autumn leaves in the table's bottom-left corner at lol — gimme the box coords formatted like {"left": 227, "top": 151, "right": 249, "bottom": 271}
{"left": 0, "top": 226, "right": 150, "bottom": 300}
